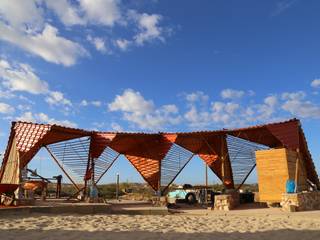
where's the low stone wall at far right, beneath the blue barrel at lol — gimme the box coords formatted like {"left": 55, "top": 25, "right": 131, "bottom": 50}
{"left": 280, "top": 192, "right": 320, "bottom": 212}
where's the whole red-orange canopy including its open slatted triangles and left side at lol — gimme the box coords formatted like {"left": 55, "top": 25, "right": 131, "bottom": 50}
{"left": 0, "top": 119, "right": 320, "bottom": 193}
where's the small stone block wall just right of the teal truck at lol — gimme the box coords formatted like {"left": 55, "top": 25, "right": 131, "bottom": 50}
{"left": 214, "top": 192, "right": 240, "bottom": 211}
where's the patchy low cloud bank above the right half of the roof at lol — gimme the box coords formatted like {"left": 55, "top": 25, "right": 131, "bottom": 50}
{"left": 184, "top": 90, "right": 320, "bottom": 129}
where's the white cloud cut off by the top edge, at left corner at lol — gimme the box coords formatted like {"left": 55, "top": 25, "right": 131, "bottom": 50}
{"left": 0, "top": 0, "right": 122, "bottom": 29}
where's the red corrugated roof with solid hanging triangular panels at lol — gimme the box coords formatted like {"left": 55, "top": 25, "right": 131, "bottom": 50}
{"left": 0, "top": 118, "right": 319, "bottom": 189}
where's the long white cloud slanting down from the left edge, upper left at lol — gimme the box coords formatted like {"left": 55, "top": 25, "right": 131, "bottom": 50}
{"left": 0, "top": 22, "right": 88, "bottom": 66}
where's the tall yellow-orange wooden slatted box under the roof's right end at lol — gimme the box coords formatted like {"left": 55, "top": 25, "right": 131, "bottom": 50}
{"left": 256, "top": 148, "right": 307, "bottom": 202}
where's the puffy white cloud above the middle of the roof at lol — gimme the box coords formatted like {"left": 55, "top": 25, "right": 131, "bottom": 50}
{"left": 108, "top": 89, "right": 181, "bottom": 131}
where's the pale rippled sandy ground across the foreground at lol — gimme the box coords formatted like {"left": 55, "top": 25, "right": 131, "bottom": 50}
{"left": 0, "top": 211, "right": 320, "bottom": 240}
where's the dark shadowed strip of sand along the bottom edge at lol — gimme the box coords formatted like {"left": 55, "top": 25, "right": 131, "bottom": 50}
{"left": 0, "top": 229, "right": 320, "bottom": 240}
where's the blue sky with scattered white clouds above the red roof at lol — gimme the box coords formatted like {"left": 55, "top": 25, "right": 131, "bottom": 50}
{"left": 0, "top": 0, "right": 320, "bottom": 185}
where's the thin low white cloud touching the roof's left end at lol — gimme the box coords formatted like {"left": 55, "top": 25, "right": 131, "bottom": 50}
{"left": 16, "top": 111, "right": 77, "bottom": 127}
